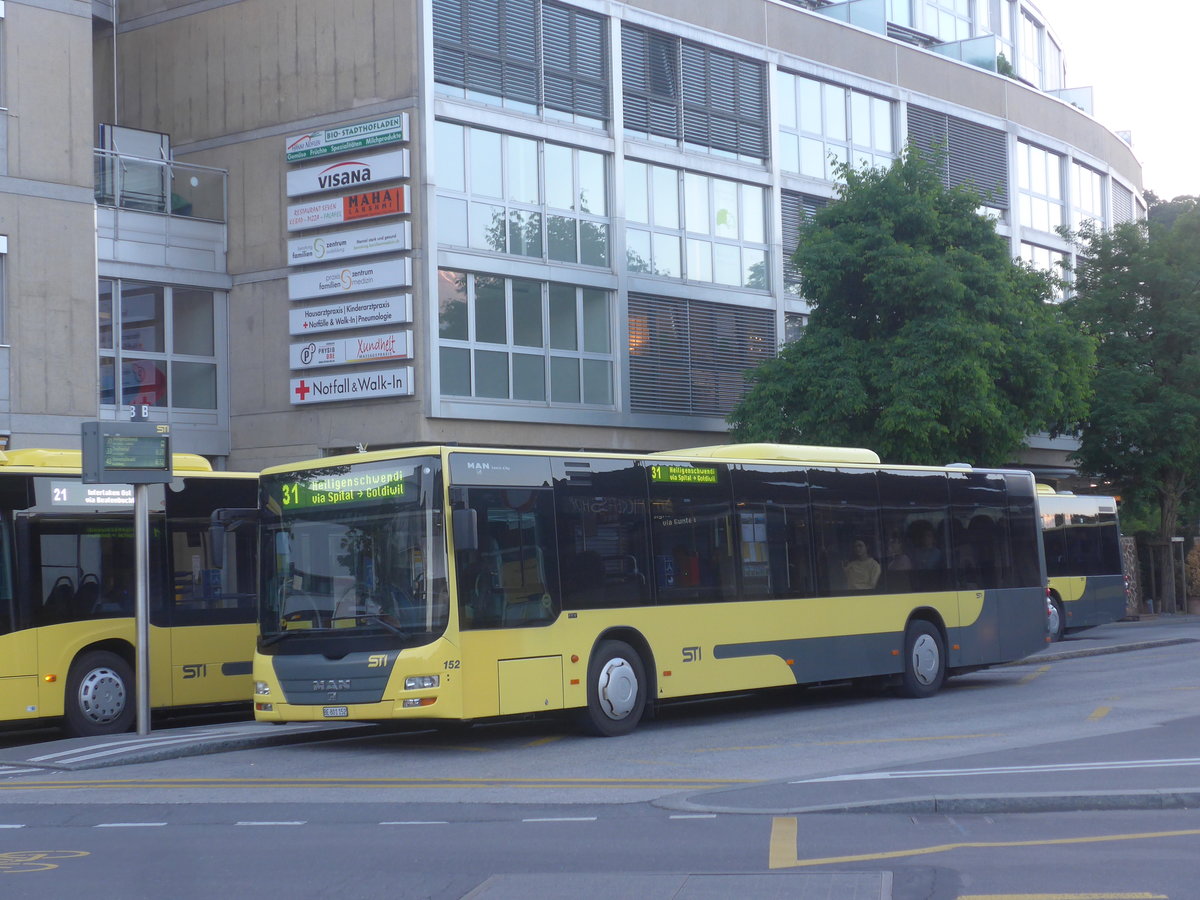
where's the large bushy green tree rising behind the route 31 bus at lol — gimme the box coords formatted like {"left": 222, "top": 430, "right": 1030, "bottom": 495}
{"left": 730, "top": 151, "right": 1092, "bottom": 464}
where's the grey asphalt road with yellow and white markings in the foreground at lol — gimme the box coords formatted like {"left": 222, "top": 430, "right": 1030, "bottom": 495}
{"left": 0, "top": 617, "right": 1200, "bottom": 900}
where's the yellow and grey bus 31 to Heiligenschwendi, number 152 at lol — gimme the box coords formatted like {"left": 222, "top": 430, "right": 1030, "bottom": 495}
{"left": 254, "top": 444, "right": 1045, "bottom": 736}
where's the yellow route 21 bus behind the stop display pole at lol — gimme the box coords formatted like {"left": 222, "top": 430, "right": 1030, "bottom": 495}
{"left": 0, "top": 449, "right": 258, "bottom": 736}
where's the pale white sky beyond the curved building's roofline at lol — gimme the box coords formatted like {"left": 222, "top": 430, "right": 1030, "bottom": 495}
{"left": 1033, "top": 0, "right": 1200, "bottom": 199}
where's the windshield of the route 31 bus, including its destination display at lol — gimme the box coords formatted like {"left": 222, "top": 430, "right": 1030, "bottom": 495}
{"left": 259, "top": 457, "right": 449, "bottom": 653}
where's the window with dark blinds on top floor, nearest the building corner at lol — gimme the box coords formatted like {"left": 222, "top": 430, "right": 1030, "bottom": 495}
{"left": 433, "top": 0, "right": 608, "bottom": 127}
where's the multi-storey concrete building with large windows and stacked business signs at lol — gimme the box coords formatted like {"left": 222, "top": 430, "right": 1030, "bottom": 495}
{"left": 0, "top": 0, "right": 1144, "bottom": 468}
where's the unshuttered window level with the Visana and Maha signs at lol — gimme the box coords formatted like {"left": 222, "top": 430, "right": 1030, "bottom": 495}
{"left": 437, "top": 121, "right": 611, "bottom": 268}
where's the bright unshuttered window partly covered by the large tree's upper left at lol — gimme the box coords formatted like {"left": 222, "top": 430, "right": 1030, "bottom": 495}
{"left": 775, "top": 71, "right": 895, "bottom": 181}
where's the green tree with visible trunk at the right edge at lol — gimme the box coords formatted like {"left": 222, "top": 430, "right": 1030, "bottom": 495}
{"left": 1064, "top": 211, "right": 1200, "bottom": 604}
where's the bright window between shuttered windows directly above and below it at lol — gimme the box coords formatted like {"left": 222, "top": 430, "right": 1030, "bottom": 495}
{"left": 625, "top": 160, "right": 769, "bottom": 290}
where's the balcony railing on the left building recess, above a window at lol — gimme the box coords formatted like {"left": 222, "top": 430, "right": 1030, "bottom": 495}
{"left": 92, "top": 150, "right": 229, "bottom": 222}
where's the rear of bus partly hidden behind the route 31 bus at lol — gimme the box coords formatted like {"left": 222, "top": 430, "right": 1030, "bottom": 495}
{"left": 1038, "top": 484, "right": 1129, "bottom": 641}
